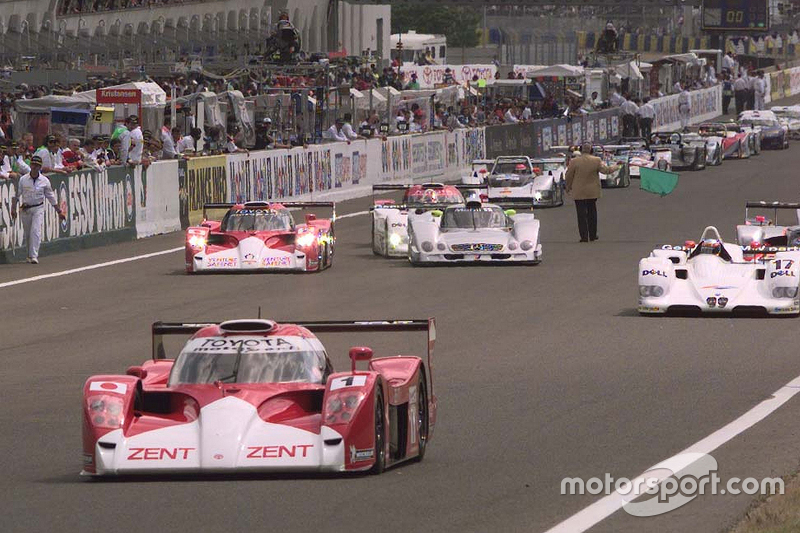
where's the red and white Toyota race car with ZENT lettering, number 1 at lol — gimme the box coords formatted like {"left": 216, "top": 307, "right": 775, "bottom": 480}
{"left": 82, "top": 318, "right": 436, "bottom": 476}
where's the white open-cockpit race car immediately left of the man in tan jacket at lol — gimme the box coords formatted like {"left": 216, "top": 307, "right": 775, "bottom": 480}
{"left": 462, "top": 156, "right": 566, "bottom": 208}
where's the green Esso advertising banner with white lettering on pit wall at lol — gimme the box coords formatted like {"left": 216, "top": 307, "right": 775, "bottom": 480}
{"left": 0, "top": 167, "right": 136, "bottom": 262}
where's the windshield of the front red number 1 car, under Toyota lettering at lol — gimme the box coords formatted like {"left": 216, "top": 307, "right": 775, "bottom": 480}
{"left": 169, "top": 336, "right": 329, "bottom": 386}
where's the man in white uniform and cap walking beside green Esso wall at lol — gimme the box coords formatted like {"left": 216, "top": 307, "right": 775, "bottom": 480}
{"left": 11, "top": 155, "right": 66, "bottom": 265}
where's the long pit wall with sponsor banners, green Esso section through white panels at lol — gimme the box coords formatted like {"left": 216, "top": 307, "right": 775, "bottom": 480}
{"left": 0, "top": 124, "right": 485, "bottom": 263}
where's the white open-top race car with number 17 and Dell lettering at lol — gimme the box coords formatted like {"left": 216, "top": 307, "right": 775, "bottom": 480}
{"left": 638, "top": 226, "right": 800, "bottom": 315}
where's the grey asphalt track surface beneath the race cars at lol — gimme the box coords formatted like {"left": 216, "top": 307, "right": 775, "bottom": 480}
{"left": 0, "top": 105, "right": 800, "bottom": 533}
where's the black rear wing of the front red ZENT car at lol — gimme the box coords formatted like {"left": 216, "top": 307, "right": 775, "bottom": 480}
{"left": 152, "top": 317, "right": 436, "bottom": 394}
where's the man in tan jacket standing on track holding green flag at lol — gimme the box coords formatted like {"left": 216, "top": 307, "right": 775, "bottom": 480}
{"left": 567, "top": 142, "right": 619, "bottom": 242}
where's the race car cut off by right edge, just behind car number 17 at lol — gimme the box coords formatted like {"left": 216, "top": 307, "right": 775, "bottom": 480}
{"left": 736, "top": 202, "right": 800, "bottom": 248}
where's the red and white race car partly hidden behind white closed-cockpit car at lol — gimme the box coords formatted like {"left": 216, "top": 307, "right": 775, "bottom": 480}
{"left": 371, "top": 183, "right": 464, "bottom": 257}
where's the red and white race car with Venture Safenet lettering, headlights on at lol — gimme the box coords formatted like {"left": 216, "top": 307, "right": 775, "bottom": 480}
{"left": 186, "top": 202, "right": 336, "bottom": 273}
